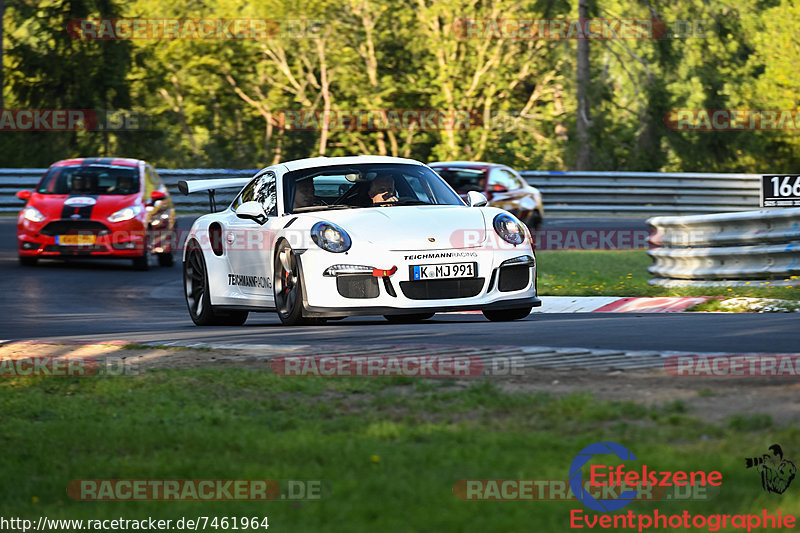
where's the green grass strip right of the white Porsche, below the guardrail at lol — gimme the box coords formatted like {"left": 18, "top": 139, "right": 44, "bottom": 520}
{"left": 536, "top": 250, "right": 800, "bottom": 300}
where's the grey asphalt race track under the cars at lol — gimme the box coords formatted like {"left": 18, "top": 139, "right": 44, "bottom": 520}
{"left": 0, "top": 217, "right": 800, "bottom": 353}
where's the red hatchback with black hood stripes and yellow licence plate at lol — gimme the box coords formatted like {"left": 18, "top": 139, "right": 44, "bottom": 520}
{"left": 17, "top": 157, "right": 175, "bottom": 270}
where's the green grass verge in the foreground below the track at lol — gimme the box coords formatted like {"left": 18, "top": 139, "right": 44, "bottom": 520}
{"left": 0, "top": 369, "right": 800, "bottom": 532}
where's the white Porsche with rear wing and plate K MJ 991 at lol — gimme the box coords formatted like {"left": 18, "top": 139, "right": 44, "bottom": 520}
{"left": 179, "top": 156, "right": 541, "bottom": 325}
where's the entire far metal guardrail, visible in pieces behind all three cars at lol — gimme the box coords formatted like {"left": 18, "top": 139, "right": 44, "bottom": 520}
{"left": 0, "top": 169, "right": 760, "bottom": 216}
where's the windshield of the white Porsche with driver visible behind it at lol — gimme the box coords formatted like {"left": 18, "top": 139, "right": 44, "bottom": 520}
{"left": 284, "top": 163, "right": 464, "bottom": 212}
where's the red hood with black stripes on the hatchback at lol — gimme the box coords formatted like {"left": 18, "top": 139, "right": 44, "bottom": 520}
{"left": 28, "top": 193, "right": 139, "bottom": 220}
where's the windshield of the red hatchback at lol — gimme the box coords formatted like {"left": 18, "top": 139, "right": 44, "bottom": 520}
{"left": 36, "top": 165, "right": 139, "bottom": 195}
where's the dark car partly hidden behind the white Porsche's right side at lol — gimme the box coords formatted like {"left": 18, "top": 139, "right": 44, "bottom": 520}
{"left": 428, "top": 161, "right": 544, "bottom": 230}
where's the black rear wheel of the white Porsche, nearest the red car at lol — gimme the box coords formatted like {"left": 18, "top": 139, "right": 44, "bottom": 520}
{"left": 183, "top": 247, "right": 248, "bottom": 326}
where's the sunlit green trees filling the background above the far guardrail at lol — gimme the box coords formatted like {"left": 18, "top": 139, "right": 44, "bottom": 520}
{"left": 0, "top": 0, "right": 800, "bottom": 172}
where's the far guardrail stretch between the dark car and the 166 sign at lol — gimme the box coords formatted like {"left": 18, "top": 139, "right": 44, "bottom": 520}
{"left": 520, "top": 170, "right": 761, "bottom": 216}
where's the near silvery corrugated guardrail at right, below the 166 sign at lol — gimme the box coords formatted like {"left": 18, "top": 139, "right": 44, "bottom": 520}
{"left": 647, "top": 208, "right": 800, "bottom": 287}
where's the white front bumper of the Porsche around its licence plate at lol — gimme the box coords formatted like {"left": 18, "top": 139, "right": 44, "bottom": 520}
{"left": 298, "top": 246, "right": 541, "bottom": 317}
